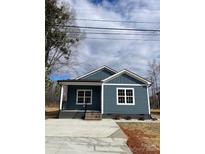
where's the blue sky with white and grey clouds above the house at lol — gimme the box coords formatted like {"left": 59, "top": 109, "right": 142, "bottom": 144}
{"left": 50, "top": 0, "right": 160, "bottom": 79}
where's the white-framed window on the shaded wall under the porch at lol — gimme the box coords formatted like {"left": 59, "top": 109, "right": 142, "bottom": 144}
{"left": 76, "top": 89, "right": 92, "bottom": 105}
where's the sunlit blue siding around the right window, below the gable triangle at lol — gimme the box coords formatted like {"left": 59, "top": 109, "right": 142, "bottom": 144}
{"left": 104, "top": 85, "right": 149, "bottom": 114}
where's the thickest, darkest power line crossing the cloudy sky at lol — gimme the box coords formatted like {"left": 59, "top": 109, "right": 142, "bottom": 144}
{"left": 65, "top": 25, "right": 160, "bottom": 32}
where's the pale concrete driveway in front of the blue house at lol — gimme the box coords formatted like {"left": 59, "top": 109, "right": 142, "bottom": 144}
{"left": 46, "top": 119, "right": 132, "bottom": 154}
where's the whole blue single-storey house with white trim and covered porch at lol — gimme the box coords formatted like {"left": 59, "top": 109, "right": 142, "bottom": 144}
{"left": 58, "top": 66, "right": 151, "bottom": 119}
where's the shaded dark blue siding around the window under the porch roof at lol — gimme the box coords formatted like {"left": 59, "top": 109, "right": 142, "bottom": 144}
{"left": 64, "top": 85, "right": 101, "bottom": 110}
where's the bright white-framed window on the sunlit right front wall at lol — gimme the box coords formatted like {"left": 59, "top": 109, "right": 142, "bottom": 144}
{"left": 116, "top": 88, "right": 135, "bottom": 105}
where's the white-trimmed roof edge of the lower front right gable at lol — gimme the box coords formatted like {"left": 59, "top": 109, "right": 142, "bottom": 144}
{"left": 102, "top": 69, "right": 151, "bottom": 85}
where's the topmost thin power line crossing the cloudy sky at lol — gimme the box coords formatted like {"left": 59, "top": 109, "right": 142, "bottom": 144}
{"left": 72, "top": 18, "right": 159, "bottom": 24}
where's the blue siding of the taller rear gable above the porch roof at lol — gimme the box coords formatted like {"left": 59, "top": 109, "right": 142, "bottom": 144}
{"left": 80, "top": 69, "right": 114, "bottom": 80}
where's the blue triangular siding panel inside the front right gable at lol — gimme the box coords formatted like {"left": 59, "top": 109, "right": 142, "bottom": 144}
{"left": 108, "top": 74, "right": 144, "bottom": 84}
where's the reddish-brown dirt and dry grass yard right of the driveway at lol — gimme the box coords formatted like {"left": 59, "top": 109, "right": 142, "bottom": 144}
{"left": 118, "top": 122, "right": 160, "bottom": 154}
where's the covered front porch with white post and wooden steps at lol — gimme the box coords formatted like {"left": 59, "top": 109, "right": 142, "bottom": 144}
{"left": 59, "top": 82, "right": 103, "bottom": 120}
